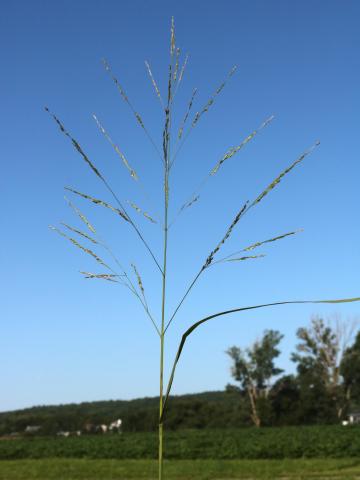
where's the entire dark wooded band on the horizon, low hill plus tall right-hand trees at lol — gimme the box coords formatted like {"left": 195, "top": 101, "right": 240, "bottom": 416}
{"left": 0, "top": 317, "right": 360, "bottom": 435}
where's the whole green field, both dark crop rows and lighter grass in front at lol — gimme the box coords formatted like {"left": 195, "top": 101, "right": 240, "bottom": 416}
{"left": 0, "top": 426, "right": 360, "bottom": 480}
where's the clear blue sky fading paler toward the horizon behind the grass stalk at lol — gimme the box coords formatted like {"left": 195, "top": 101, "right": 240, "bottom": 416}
{"left": 0, "top": 0, "right": 360, "bottom": 411}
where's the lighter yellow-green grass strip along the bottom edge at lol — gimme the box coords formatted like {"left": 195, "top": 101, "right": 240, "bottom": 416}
{"left": 0, "top": 459, "right": 360, "bottom": 480}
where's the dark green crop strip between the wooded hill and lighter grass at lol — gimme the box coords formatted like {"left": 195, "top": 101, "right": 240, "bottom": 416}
{"left": 0, "top": 426, "right": 360, "bottom": 460}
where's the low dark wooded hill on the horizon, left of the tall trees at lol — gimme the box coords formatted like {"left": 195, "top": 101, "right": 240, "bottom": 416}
{"left": 0, "top": 391, "right": 250, "bottom": 435}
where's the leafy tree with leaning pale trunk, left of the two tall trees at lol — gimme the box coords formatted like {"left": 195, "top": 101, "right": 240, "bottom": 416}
{"left": 226, "top": 330, "right": 283, "bottom": 427}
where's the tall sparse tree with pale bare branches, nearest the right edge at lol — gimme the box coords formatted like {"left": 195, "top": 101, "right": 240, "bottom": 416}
{"left": 292, "top": 316, "right": 355, "bottom": 419}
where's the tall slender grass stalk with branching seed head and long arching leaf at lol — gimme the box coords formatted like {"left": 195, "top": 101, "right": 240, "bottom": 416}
{"left": 46, "top": 19, "right": 359, "bottom": 480}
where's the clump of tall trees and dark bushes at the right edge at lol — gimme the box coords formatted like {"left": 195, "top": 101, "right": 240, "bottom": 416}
{"left": 226, "top": 316, "right": 360, "bottom": 427}
